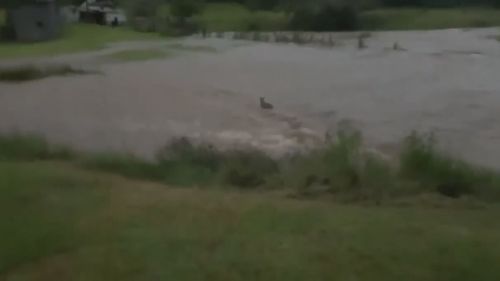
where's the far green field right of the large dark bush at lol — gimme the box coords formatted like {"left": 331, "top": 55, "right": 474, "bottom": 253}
{"left": 361, "top": 8, "right": 500, "bottom": 30}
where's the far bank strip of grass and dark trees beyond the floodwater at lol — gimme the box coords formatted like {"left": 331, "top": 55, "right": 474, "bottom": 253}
{"left": 122, "top": 0, "right": 500, "bottom": 35}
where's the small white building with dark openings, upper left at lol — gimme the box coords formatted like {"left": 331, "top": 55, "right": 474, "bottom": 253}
{"left": 78, "top": 0, "right": 127, "bottom": 25}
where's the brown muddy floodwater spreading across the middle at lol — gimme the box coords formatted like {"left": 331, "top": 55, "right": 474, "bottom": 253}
{"left": 0, "top": 29, "right": 500, "bottom": 168}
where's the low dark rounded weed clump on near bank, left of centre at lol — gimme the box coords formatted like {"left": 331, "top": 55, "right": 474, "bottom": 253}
{"left": 158, "top": 138, "right": 279, "bottom": 188}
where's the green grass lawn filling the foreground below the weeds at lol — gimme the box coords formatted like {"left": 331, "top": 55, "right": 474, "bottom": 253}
{"left": 0, "top": 161, "right": 500, "bottom": 281}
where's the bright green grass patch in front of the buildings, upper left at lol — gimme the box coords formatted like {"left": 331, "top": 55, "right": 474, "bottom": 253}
{"left": 0, "top": 24, "right": 160, "bottom": 59}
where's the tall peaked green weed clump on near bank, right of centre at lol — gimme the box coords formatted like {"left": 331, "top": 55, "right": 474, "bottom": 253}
{"left": 287, "top": 131, "right": 395, "bottom": 202}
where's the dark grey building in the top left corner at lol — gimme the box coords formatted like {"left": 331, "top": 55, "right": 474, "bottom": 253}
{"left": 7, "top": 0, "right": 63, "bottom": 42}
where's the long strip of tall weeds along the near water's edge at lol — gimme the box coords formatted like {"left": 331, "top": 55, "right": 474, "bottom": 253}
{"left": 0, "top": 130, "right": 500, "bottom": 203}
